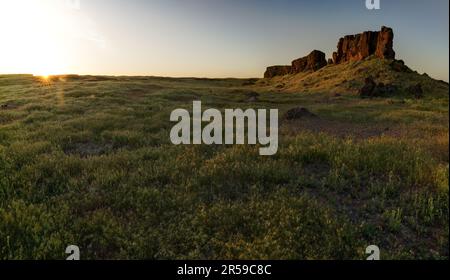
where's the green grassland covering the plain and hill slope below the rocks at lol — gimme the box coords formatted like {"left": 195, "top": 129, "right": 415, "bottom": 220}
{"left": 0, "top": 58, "right": 449, "bottom": 259}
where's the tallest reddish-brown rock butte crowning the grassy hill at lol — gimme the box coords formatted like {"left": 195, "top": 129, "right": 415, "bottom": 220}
{"left": 333, "top": 26, "right": 395, "bottom": 64}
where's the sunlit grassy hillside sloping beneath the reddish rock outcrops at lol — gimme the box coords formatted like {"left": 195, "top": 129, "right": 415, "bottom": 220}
{"left": 258, "top": 56, "right": 448, "bottom": 97}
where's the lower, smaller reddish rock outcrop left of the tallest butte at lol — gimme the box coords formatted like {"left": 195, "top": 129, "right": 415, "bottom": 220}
{"left": 264, "top": 50, "right": 327, "bottom": 78}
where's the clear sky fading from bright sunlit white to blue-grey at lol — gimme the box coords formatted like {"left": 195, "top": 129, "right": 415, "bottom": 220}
{"left": 0, "top": 0, "right": 449, "bottom": 81}
